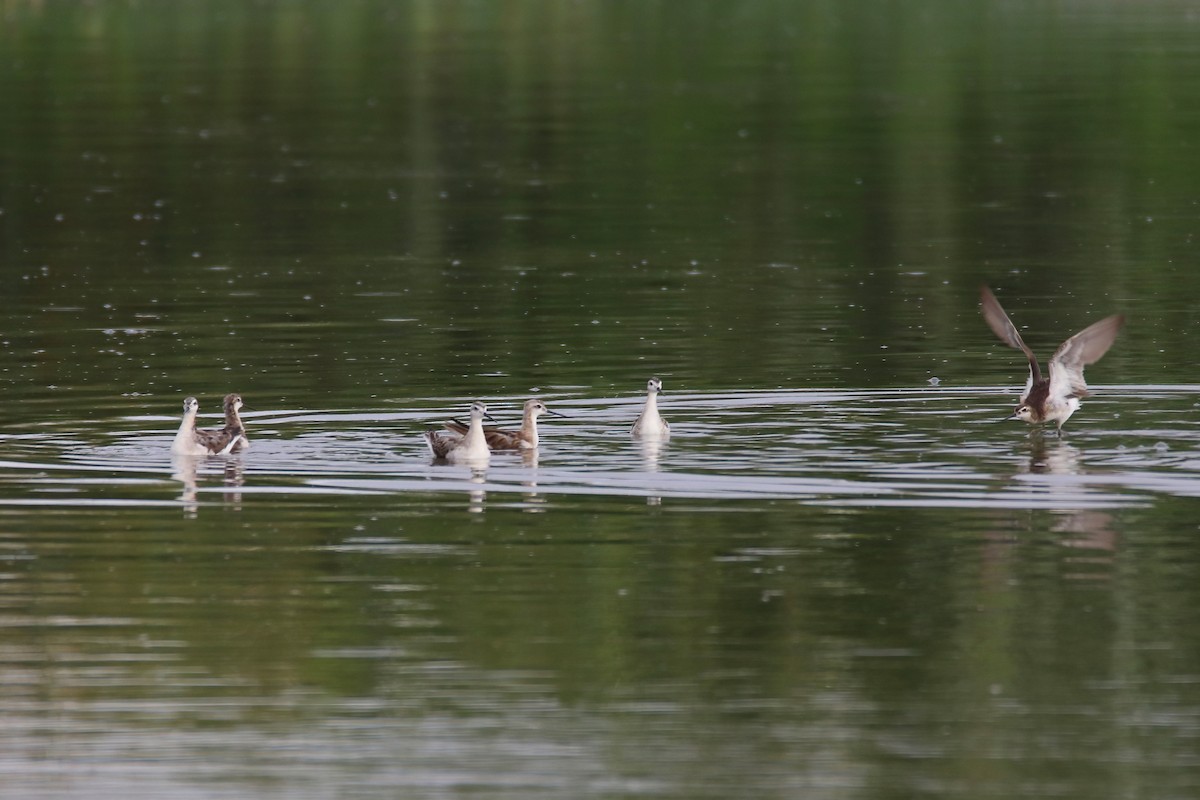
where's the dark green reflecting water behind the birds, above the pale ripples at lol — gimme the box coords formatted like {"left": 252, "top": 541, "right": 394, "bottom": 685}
{"left": 0, "top": 2, "right": 1200, "bottom": 404}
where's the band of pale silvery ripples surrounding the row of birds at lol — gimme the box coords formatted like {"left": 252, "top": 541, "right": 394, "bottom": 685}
{"left": 0, "top": 386, "right": 1200, "bottom": 509}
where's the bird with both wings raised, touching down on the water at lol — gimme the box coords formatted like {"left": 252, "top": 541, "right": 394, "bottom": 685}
{"left": 979, "top": 281, "right": 1124, "bottom": 437}
